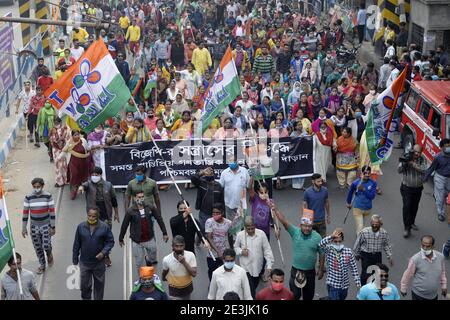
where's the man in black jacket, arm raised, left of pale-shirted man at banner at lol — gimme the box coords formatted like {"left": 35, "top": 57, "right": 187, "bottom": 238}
{"left": 191, "top": 167, "right": 225, "bottom": 233}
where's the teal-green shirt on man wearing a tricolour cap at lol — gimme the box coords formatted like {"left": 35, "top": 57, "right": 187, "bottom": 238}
{"left": 287, "top": 224, "right": 322, "bottom": 270}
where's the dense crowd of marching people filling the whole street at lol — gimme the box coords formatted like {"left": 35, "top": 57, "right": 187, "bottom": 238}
{"left": 2, "top": 0, "right": 450, "bottom": 300}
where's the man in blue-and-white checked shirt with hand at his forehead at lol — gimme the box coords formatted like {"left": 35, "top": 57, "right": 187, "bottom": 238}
{"left": 320, "top": 228, "right": 361, "bottom": 300}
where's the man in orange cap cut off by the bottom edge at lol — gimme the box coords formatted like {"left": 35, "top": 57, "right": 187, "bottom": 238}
{"left": 130, "top": 267, "right": 169, "bottom": 300}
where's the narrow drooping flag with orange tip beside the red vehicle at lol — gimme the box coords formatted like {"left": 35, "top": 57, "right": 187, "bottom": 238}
{"left": 366, "top": 67, "right": 408, "bottom": 164}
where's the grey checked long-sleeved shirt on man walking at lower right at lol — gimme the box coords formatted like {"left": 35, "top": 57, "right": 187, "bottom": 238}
{"left": 353, "top": 227, "right": 392, "bottom": 258}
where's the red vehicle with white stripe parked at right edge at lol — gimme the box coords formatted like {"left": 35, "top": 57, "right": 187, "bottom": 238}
{"left": 400, "top": 81, "right": 450, "bottom": 162}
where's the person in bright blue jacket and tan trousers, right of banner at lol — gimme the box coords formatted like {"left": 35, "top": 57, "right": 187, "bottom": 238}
{"left": 347, "top": 166, "right": 377, "bottom": 235}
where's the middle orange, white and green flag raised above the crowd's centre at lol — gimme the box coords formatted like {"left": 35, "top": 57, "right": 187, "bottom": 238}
{"left": 201, "top": 46, "right": 241, "bottom": 132}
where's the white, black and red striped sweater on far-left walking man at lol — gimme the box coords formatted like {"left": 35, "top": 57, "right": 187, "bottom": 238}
{"left": 22, "top": 191, "right": 55, "bottom": 231}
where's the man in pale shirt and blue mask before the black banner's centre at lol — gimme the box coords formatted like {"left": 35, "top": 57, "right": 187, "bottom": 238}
{"left": 219, "top": 158, "right": 250, "bottom": 221}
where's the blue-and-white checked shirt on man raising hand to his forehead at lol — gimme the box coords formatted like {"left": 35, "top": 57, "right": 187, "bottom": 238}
{"left": 319, "top": 236, "right": 361, "bottom": 289}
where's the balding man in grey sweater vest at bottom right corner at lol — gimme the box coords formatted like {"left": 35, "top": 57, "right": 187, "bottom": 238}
{"left": 400, "top": 235, "right": 447, "bottom": 300}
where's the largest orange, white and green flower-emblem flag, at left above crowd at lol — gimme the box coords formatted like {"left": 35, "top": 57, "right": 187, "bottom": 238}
{"left": 45, "top": 38, "right": 131, "bottom": 132}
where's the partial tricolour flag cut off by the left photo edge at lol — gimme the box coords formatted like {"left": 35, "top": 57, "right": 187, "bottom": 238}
{"left": 0, "top": 175, "right": 14, "bottom": 272}
